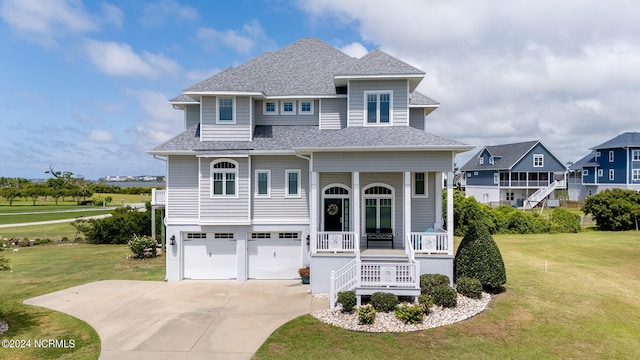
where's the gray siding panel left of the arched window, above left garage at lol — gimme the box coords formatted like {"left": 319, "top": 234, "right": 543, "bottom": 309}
{"left": 167, "top": 155, "right": 198, "bottom": 222}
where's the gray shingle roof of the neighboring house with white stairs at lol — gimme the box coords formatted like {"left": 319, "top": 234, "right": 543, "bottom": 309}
{"left": 460, "top": 140, "right": 540, "bottom": 171}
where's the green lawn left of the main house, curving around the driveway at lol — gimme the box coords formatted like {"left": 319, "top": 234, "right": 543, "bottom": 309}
{"left": 0, "top": 243, "right": 164, "bottom": 359}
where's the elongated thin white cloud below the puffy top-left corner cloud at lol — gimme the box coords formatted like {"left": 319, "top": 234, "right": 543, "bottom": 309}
{"left": 84, "top": 39, "right": 181, "bottom": 78}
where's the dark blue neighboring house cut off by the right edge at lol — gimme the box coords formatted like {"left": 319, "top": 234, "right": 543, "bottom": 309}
{"left": 569, "top": 132, "right": 640, "bottom": 200}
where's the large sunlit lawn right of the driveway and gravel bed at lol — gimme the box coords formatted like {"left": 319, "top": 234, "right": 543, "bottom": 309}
{"left": 255, "top": 231, "right": 640, "bottom": 359}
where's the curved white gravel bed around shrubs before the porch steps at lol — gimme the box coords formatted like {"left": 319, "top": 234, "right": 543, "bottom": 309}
{"left": 311, "top": 292, "right": 491, "bottom": 332}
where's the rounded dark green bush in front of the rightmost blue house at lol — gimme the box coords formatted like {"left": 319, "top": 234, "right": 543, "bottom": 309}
{"left": 582, "top": 189, "right": 640, "bottom": 231}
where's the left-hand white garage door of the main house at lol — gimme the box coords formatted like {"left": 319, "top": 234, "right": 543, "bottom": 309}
{"left": 184, "top": 239, "right": 237, "bottom": 280}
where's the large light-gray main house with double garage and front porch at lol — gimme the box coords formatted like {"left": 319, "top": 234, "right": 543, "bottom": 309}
{"left": 149, "top": 38, "right": 472, "bottom": 306}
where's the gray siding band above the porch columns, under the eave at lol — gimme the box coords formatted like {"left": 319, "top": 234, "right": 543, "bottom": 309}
{"left": 313, "top": 151, "right": 452, "bottom": 172}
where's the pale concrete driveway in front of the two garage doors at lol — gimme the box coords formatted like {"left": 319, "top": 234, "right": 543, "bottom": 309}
{"left": 25, "top": 280, "right": 329, "bottom": 360}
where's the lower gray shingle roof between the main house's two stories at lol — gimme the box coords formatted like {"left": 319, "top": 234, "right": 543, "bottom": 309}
{"left": 149, "top": 125, "right": 471, "bottom": 154}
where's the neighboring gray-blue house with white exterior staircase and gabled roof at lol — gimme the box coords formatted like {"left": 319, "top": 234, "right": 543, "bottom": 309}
{"left": 460, "top": 140, "right": 568, "bottom": 208}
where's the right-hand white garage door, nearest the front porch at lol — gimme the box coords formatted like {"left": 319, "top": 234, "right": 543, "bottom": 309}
{"left": 248, "top": 238, "right": 302, "bottom": 279}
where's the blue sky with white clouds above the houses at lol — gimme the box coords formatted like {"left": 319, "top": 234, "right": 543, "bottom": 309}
{"left": 0, "top": 0, "right": 640, "bottom": 179}
